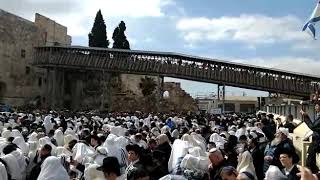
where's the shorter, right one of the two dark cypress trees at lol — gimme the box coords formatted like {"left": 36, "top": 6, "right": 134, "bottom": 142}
{"left": 112, "top": 21, "right": 130, "bottom": 49}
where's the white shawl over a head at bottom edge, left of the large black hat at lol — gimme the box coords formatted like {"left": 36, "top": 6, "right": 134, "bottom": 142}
{"left": 37, "top": 156, "right": 69, "bottom": 180}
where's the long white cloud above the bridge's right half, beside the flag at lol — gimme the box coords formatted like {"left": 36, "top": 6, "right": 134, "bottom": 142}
{"left": 176, "top": 15, "right": 310, "bottom": 47}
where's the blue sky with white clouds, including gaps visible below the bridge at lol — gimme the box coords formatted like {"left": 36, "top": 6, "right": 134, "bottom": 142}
{"left": 0, "top": 0, "right": 320, "bottom": 95}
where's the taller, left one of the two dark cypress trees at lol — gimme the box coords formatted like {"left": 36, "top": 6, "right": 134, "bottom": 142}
{"left": 88, "top": 10, "right": 109, "bottom": 48}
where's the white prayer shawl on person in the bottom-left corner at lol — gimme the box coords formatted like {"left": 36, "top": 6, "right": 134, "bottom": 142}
{"left": 1, "top": 154, "right": 22, "bottom": 180}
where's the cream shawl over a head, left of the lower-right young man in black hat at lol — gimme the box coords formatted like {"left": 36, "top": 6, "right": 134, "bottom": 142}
{"left": 237, "top": 151, "right": 257, "bottom": 179}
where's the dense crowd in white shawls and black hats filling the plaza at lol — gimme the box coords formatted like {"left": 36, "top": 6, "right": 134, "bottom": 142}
{"left": 0, "top": 106, "right": 320, "bottom": 180}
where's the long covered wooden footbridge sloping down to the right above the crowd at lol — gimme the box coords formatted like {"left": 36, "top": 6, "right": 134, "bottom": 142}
{"left": 33, "top": 46, "right": 320, "bottom": 97}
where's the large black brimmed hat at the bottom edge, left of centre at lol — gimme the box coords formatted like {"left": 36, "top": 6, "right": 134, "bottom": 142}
{"left": 97, "top": 156, "right": 121, "bottom": 176}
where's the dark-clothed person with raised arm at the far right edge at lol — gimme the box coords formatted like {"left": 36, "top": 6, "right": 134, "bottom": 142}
{"left": 300, "top": 96, "right": 320, "bottom": 173}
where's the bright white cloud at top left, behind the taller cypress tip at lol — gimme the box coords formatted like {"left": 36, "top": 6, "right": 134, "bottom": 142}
{"left": 0, "top": 0, "right": 174, "bottom": 36}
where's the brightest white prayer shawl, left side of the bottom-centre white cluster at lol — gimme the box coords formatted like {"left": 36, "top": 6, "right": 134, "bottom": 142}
{"left": 168, "top": 139, "right": 190, "bottom": 173}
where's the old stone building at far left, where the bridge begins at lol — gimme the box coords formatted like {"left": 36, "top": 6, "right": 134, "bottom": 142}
{"left": 0, "top": 9, "right": 71, "bottom": 106}
